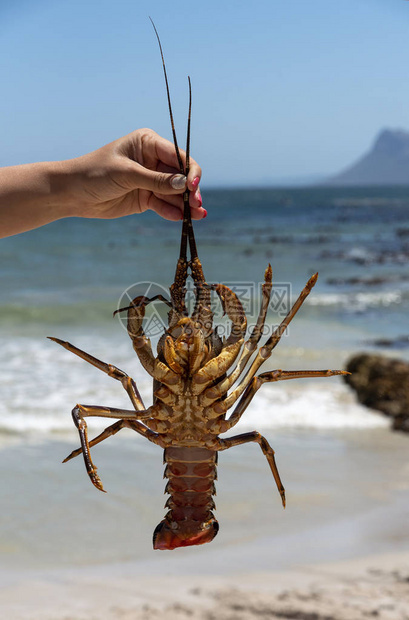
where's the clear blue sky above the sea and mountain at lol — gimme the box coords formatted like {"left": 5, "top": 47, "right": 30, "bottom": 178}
{"left": 0, "top": 0, "right": 409, "bottom": 187}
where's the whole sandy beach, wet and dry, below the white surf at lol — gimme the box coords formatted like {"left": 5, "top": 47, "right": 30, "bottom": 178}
{"left": 0, "top": 428, "right": 409, "bottom": 620}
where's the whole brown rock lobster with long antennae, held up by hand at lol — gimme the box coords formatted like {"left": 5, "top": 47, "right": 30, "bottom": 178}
{"left": 50, "top": 22, "right": 347, "bottom": 549}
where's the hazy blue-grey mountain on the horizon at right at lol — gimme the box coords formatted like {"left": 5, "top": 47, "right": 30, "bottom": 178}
{"left": 325, "top": 129, "right": 409, "bottom": 185}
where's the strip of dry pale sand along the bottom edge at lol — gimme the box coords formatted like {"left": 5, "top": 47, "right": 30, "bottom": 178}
{"left": 0, "top": 550, "right": 409, "bottom": 620}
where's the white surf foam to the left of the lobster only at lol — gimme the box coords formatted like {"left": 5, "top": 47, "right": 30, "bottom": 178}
{"left": 0, "top": 337, "right": 152, "bottom": 433}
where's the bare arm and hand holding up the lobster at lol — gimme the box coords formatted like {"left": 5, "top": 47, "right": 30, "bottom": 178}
{"left": 0, "top": 129, "right": 206, "bottom": 237}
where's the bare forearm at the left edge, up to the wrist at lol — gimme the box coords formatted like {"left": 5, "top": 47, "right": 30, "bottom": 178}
{"left": 0, "top": 162, "right": 75, "bottom": 237}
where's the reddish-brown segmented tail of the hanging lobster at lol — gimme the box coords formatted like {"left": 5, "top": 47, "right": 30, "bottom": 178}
{"left": 153, "top": 448, "right": 219, "bottom": 550}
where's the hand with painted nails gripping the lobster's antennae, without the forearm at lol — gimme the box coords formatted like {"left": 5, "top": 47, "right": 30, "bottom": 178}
{"left": 68, "top": 129, "right": 207, "bottom": 221}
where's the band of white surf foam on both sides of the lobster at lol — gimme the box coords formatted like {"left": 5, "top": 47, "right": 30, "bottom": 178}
{"left": 0, "top": 336, "right": 388, "bottom": 435}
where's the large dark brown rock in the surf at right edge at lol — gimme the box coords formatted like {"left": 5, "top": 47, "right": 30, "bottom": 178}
{"left": 344, "top": 353, "right": 409, "bottom": 433}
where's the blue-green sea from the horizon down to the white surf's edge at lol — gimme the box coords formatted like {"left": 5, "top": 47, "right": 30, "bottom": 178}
{"left": 0, "top": 188, "right": 409, "bottom": 437}
